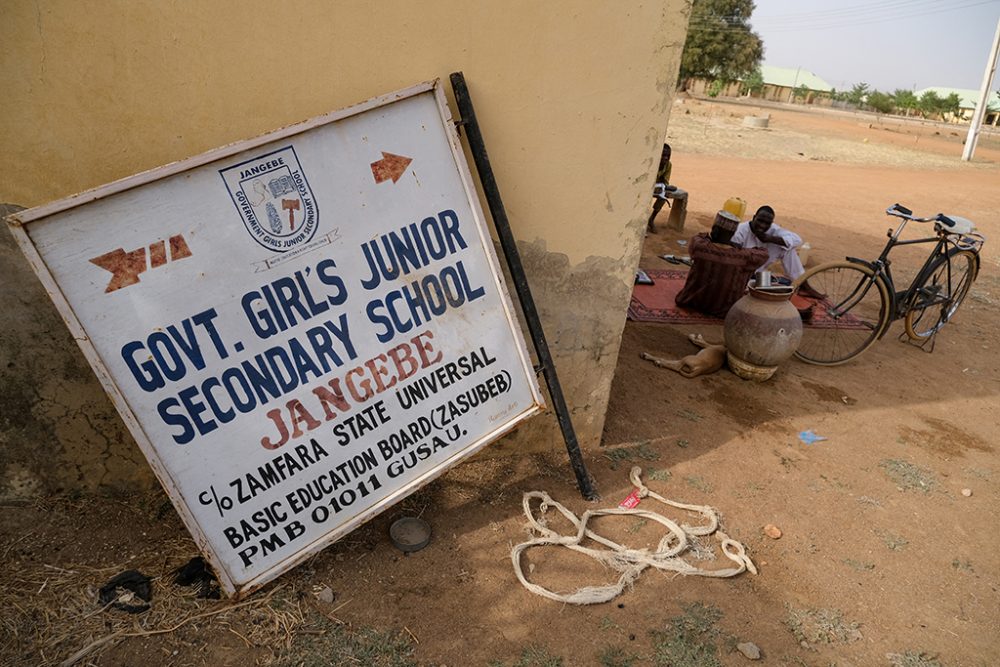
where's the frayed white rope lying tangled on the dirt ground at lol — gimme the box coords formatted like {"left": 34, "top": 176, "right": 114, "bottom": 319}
{"left": 510, "top": 467, "right": 757, "bottom": 604}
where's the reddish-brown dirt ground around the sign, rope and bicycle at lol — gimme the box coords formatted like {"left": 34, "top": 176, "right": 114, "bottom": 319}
{"left": 0, "top": 99, "right": 1000, "bottom": 667}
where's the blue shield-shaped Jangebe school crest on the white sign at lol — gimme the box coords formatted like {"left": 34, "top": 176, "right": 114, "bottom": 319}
{"left": 219, "top": 146, "right": 319, "bottom": 252}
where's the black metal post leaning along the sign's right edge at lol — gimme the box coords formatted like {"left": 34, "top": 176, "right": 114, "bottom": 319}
{"left": 451, "top": 72, "right": 598, "bottom": 500}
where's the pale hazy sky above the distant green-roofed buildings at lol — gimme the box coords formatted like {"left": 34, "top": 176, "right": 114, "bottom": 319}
{"left": 751, "top": 0, "right": 1000, "bottom": 92}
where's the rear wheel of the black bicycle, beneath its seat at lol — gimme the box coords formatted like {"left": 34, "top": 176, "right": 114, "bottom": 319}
{"left": 905, "top": 250, "right": 979, "bottom": 340}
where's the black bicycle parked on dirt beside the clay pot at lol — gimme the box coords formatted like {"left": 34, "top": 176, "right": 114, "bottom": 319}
{"left": 795, "top": 204, "right": 986, "bottom": 366}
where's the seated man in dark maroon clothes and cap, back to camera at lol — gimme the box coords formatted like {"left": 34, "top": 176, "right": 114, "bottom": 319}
{"left": 675, "top": 211, "right": 768, "bottom": 317}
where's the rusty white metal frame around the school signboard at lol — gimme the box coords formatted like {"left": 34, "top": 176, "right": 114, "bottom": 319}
{"left": 7, "top": 80, "right": 548, "bottom": 596}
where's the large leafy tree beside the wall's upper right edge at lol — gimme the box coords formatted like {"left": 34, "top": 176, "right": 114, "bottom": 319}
{"left": 680, "top": 0, "right": 764, "bottom": 82}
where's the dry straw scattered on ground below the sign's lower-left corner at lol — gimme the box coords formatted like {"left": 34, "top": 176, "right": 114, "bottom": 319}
{"left": 0, "top": 498, "right": 320, "bottom": 667}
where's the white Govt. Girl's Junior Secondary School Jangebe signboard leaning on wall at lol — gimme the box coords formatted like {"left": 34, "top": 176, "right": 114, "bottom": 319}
{"left": 11, "top": 82, "right": 542, "bottom": 593}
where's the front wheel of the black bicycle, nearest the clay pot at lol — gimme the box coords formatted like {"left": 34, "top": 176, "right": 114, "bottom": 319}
{"left": 795, "top": 261, "right": 890, "bottom": 366}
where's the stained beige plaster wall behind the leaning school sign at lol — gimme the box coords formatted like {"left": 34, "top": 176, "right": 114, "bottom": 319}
{"left": 0, "top": 0, "right": 690, "bottom": 496}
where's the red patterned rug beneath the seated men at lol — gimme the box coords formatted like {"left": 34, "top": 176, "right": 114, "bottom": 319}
{"left": 628, "top": 269, "right": 866, "bottom": 329}
